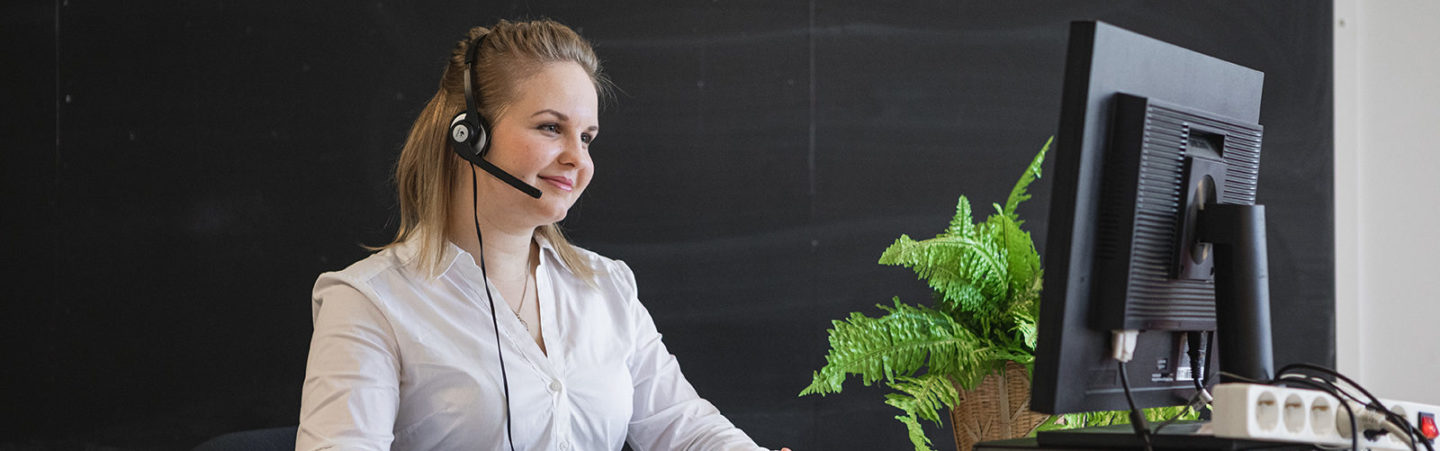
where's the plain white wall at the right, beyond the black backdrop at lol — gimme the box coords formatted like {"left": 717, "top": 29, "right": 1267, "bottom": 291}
{"left": 1333, "top": 0, "right": 1440, "bottom": 405}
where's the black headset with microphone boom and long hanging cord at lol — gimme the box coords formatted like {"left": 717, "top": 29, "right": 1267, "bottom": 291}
{"left": 449, "top": 32, "right": 540, "bottom": 451}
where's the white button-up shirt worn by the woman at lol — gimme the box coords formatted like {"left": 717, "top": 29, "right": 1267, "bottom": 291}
{"left": 297, "top": 235, "right": 762, "bottom": 451}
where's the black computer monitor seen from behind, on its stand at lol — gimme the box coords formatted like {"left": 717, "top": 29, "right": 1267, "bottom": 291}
{"left": 1031, "top": 22, "right": 1273, "bottom": 414}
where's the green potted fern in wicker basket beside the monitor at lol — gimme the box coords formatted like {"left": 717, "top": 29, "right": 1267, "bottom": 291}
{"left": 801, "top": 141, "right": 1050, "bottom": 451}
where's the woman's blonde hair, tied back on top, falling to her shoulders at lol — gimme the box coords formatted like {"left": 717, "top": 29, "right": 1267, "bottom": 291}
{"left": 377, "top": 20, "right": 611, "bottom": 279}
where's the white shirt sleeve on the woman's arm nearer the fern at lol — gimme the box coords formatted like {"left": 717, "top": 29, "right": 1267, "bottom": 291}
{"left": 618, "top": 262, "right": 765, "bottom": 451}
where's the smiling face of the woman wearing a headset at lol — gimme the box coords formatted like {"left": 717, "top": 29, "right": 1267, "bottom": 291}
{"left": 465, "top": 62, "right": 600, "bottom": 226}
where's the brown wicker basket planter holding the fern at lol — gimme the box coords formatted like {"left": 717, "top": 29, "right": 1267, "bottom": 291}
{"left": 950, "top": 362, "right": 1050, "bottom": 451}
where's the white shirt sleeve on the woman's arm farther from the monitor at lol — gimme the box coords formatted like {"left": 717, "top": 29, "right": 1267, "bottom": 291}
{"left": 295, "top": 277, "right": 400, "bottom": 451}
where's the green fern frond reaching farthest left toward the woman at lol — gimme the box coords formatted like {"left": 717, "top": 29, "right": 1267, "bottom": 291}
{"left": 801, "top": 298, "right": 994, "bottom": 396}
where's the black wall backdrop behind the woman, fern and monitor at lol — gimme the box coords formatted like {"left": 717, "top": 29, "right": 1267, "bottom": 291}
{"left": 0, "top": 0, "right": 1333, "bottom": 450}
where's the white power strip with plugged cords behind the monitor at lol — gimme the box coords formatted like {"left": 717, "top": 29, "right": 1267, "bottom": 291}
{"left": 1211, "top": 383, "right": 1440, "bottom": 451}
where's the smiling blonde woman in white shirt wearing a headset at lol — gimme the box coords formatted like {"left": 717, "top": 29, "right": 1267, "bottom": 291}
{"left": 297, "top": 20, "right": 789, "bottom": 450}
